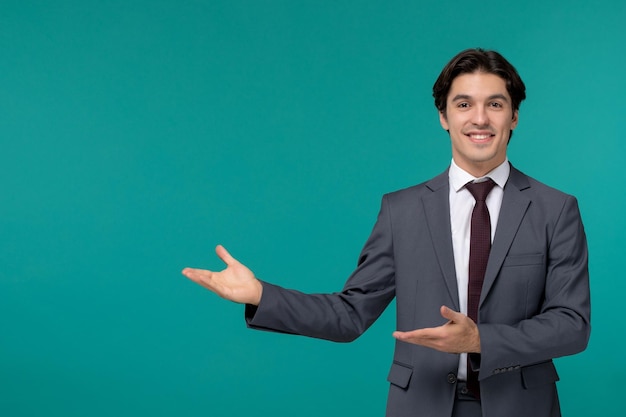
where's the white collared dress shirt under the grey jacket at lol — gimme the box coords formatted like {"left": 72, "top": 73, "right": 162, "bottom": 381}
{"left": 448, "top": 159, "right": 511, "bottom": 381}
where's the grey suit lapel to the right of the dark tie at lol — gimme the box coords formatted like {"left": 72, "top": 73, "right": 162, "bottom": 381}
{"left": 479, "top": 166, "right": 530, "bottom": 308}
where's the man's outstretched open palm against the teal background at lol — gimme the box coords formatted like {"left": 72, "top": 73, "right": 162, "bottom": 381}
{"left": 183, "top": 245, "right": 263, "bottom": 305}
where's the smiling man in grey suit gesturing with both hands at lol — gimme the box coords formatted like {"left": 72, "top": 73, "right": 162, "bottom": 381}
{"left": 183, "top": 49, "right": 590, "bottom": 417}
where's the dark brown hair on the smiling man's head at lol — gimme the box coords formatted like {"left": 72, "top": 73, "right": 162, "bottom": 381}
{"left": 433, "top": 48, "right": 526, "bottom": 115}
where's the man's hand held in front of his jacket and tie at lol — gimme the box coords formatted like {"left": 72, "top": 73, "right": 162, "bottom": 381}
{"left": 393, "top": 306, "right": 480, "bottom": 353}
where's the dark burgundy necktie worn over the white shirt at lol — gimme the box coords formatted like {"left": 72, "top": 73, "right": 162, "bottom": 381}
{"left": 465, "top": 178, "right": 496, "bottom": 398}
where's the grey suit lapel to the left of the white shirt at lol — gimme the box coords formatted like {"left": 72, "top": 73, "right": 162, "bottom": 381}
{"left": 422, "top": 171, "right": 459, "bottom": 311}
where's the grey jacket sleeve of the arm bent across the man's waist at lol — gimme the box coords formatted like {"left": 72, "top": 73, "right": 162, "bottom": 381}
{"left": 472, "top": 196, "right": 591, "bottom": 380}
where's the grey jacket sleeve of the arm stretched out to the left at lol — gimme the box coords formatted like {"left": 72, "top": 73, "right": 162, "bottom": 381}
{"left": 245, "top": 197, "right": 395, "bottom": 342}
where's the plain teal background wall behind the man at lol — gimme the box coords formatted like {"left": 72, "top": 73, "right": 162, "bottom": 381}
{"left": 0, "top": 0, "right": 626, "bottom": 417}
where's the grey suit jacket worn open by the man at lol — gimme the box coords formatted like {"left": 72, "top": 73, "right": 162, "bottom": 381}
{"left": 246, "top": 167, "right": 590, "bottom": 417}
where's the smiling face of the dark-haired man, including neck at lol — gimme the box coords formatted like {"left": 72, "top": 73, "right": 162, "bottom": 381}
{"left": 439, "top": 72, "right": 517, "bottom": 177}
